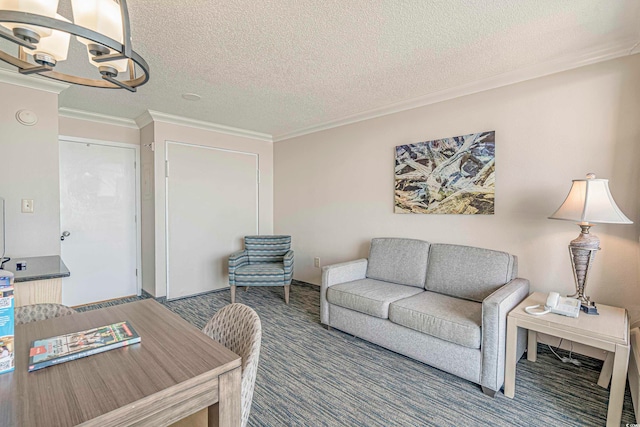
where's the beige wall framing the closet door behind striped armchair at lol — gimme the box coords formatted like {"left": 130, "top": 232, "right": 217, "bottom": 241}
{"left": 151, "top": 121, "right": 273, "bottom": 297}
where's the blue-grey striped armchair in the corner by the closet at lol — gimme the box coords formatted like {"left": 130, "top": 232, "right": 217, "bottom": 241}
{"left": 229, "top": 236, "right": 293, "bottom": 304}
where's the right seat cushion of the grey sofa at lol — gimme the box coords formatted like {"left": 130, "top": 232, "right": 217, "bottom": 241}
{"left": 389, "top": 292, "right": 482, "bottom": 348}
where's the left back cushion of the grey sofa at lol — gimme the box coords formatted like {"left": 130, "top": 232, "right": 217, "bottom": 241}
{"left": 367, "top": 238, "right": 429, "bottom": 288}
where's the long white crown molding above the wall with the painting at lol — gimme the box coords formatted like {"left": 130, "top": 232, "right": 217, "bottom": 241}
{"left": 273, "top": 38, "right": 640, "bottom": 142}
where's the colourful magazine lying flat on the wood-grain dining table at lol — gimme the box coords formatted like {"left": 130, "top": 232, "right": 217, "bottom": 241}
{"left": 29, "top": 322, "right": 140, "bottom": 372}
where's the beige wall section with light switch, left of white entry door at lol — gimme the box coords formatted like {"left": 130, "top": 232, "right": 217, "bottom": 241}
{"left": 0, "top": 83, "right": 60, "bottom": 258}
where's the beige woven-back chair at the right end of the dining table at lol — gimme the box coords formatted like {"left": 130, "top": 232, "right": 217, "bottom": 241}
{"left": 202, "top": 304, "right": 262, "bottom": 427}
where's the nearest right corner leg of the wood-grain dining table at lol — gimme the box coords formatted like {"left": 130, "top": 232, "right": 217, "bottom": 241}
{"left": 209, "top": 367, "right": 242, "bottom": 427}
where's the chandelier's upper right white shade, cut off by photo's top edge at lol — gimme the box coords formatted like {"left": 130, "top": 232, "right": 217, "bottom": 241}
{"left": 71, "top": 0, "right": 124, "bottom": 44}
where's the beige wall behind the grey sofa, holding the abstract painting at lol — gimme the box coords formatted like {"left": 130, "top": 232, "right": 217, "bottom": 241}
{"left": 274, "top": 55, "right": 640, "bottom": 308}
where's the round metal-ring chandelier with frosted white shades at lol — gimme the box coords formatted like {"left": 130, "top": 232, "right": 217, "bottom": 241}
{"left": 0, "top": 0, "right": 149, "bottom": 92}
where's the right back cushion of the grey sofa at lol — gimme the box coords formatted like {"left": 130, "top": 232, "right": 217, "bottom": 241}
{"left": 425, "top": 244, "right": 518, "bottom": 302}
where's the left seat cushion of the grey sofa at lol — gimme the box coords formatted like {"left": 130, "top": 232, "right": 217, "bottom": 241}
{"left": 327, "top": 279, "right": 424, "bottom": 319}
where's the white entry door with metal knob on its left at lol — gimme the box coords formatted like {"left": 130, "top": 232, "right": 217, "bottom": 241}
{"left": 60, "top": 140, "right": 138, "bottom": 306}
